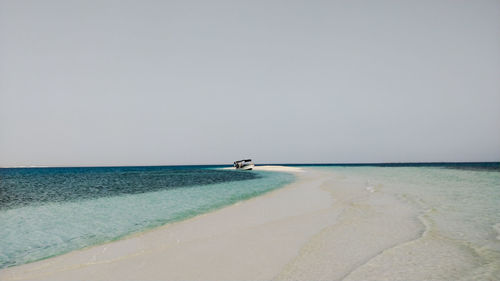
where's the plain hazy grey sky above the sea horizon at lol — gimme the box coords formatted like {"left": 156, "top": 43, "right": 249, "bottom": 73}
{"left": 0, "top": 0, "right": 500, "bottom": 166}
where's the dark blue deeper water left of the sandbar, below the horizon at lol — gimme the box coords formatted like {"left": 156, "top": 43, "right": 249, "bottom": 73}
{"left": 0, "top": 166, "right": 261, "bottom": 210}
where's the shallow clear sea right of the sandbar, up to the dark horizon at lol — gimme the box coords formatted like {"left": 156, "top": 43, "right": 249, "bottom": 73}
{"left": 315, "top": 163, "right": 500, "bottom": 280}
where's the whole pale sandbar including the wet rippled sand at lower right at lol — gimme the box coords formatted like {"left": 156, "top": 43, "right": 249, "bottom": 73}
{"left": 0, "top": 166, "right": 497, "bottom": 280}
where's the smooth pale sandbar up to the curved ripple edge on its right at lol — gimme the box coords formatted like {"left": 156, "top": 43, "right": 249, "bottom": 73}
{"left": 0, "top": 166, "right": 422, "bottom": 280}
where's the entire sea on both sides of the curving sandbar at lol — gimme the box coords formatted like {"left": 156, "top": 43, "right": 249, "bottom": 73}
{"left": 0, "top": 163, "right": 500, "bottom": 280}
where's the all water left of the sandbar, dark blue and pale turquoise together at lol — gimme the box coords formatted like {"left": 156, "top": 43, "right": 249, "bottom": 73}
{"left": 0, "top": 167, "right": 294, "bottom": 268}
